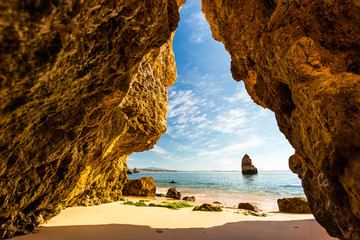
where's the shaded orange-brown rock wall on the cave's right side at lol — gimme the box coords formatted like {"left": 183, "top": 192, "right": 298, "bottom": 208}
{"left": 202, "top": 0, "right": 360, "bottom": 240}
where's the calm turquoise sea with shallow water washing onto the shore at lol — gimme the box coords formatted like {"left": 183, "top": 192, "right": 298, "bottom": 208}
{"left": 128, "top": 171, "right": 305, "bottom": 210}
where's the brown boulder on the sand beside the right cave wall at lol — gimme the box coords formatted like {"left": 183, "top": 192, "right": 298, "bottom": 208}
{"left": 277, "top": 197, "right": 311, "bottom": 213}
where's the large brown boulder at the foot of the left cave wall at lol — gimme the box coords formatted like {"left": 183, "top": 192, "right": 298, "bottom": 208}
{"left": 123, "top": 177, "right": 156, "bottom": 197}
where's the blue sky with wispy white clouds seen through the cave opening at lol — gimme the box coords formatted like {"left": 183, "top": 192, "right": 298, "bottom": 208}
{"left": 127, "top": 1, "right": 294, "bottom": 171}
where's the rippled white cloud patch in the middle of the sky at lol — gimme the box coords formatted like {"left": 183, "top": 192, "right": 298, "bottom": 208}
{"left": 167, "top": 86, "right": 267, "bottom": 141}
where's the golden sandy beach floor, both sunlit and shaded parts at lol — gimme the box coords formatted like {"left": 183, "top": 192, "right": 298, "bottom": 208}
{"left": 13, "top": 198, "right": 335, "bottom": 240}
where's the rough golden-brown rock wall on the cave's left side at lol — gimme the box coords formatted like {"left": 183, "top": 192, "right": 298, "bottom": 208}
{"left": 0, "top": 0, "right": 179, "bottom": 238}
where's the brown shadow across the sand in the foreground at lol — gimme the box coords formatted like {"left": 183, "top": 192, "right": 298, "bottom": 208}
{"left": 13, "top": 220, "right": 335, "bottom": 240}
